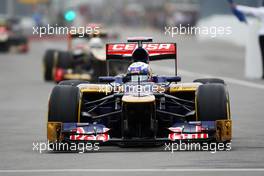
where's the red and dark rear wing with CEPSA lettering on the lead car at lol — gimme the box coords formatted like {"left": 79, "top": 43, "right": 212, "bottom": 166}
{"left": 106, "top": 43, "right": 177, "bottom": 75}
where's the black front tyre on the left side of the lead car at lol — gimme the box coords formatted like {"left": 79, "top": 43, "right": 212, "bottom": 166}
{"left": 48, "top": 85, "right": 80, "bottom": 123}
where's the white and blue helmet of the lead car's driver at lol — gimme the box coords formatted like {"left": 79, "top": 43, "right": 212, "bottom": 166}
{"left": 127, "top": 62, "right": 152, "bottom": 81}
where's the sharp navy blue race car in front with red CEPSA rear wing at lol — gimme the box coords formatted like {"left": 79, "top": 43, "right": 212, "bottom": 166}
{"left": 47, "top": 38, "right": 232, "bottom": 146}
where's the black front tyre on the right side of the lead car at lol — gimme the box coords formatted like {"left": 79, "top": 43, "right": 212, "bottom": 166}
{"left": 196, "top": 83, "right": 230, "bottom": 121}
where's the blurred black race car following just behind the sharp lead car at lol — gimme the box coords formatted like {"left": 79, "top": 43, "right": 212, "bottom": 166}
{"left": 43, "top": 28, "right": 125, "bottom": 82}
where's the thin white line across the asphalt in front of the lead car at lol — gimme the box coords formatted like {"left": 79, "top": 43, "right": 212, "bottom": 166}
{"left": 0, "top": 168, "right": 264, "bottom": 173}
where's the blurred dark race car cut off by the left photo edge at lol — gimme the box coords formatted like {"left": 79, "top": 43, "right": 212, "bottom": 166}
{"left": 0, "top": 18, "right": 29, "bottom": 53}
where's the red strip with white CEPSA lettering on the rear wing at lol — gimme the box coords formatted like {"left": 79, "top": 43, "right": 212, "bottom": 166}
{"left": 109, "top": 43, "right": 174, "bottom": 51}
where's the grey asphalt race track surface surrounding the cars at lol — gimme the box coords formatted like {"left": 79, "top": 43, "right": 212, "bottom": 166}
{"left": 0, "top": 29, "right": 264, "bottom": 176}
